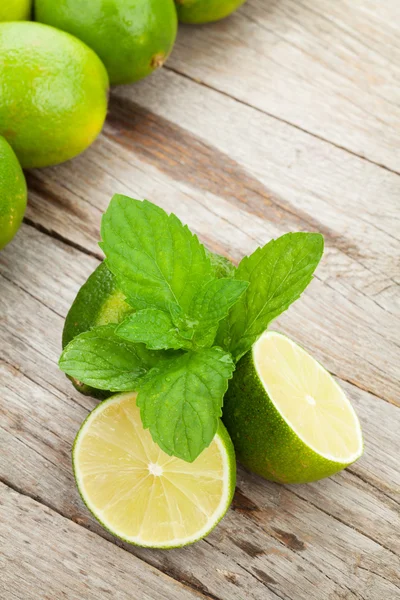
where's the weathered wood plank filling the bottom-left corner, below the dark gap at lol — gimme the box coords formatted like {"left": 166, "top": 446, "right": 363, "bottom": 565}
{"left": 0, "top": 483, "right": 209, "bottom": 600}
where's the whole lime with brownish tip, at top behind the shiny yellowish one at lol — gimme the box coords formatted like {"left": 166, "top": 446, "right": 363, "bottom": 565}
{"left": 35, "top": 0, "right": 177, "bottom": 85}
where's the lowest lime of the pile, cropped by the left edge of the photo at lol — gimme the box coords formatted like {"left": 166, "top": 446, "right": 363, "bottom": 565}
{"left": 0, "top": 136, "right": 27, "bottom": 250}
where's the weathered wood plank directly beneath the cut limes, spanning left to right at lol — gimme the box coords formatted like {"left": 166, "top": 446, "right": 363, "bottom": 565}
{"left": 0, "top": 226, "right": 399, "bottom": 600}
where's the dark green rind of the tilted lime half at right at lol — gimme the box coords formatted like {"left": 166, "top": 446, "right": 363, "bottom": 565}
{"left": 222, "top": 342, "right": 362, "bottom": 484}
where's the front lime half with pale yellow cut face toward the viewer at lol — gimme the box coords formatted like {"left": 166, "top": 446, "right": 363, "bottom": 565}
{"left": 73, "top": 392, "right": 236, "bottom": 548}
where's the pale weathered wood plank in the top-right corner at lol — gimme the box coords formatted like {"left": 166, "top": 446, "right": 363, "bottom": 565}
{"left": 168, "top": 0, "right": 400, "bottom": 172}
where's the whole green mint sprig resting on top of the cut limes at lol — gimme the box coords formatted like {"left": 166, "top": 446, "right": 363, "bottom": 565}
{"left": 60, "top": 195, "right": 323, "bottom": 462}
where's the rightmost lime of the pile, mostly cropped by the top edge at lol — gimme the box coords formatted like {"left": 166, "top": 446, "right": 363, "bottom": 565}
{"left": 175, "top": 0, "right": 246, "bottom": 24}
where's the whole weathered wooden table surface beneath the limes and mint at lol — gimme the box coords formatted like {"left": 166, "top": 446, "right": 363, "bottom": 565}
{"left": 0, "top": 0, "right": 400, "bottom": 600}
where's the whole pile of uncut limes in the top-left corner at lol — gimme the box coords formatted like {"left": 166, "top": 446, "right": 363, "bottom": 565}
{"left": 0, "top": 0, "right": 245, "bottom": 249}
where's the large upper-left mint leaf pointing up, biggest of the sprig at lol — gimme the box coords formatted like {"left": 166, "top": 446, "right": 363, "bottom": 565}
{"left": 100, "top": 194, "right": 214, "bottom": 312}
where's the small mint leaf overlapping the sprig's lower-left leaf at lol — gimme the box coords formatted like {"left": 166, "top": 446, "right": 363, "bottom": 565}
{"left": 115, "top": 308, "right": 191, "bottom": 350}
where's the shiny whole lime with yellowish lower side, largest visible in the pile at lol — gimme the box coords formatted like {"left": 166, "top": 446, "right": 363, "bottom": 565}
{"left": 0, "top": 21, "right": 108, "bottom": 168}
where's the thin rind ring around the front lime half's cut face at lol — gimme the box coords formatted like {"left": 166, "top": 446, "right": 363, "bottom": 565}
{"left": 72, "top": 392, "right": 236, "bottom": 550}
